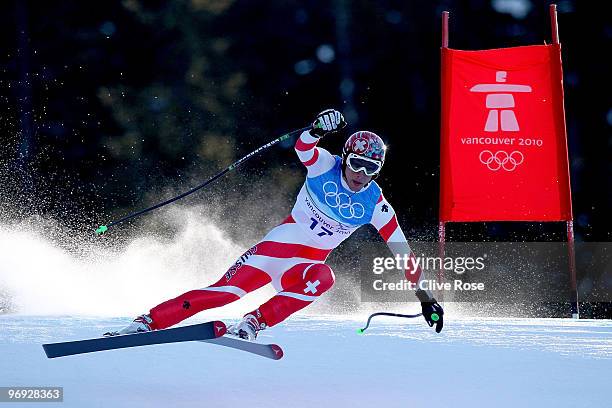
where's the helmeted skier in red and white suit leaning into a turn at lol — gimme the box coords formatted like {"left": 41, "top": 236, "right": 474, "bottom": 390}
{"left": 106, "top": 109, "right": 444, "bottom": 340}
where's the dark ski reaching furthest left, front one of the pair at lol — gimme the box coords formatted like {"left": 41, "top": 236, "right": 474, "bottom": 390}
{"left": 43, "top": 321, "right": 227, "bottom": 358}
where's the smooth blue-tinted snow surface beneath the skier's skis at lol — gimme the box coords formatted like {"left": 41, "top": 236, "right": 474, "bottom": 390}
{"left": 0, "top": 312, "right": 612, "bottom": 408}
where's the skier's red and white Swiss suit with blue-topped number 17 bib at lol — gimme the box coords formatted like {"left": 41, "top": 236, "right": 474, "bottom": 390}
{"left": 150, "top": 131, "right": 421, "bottom": 329}
